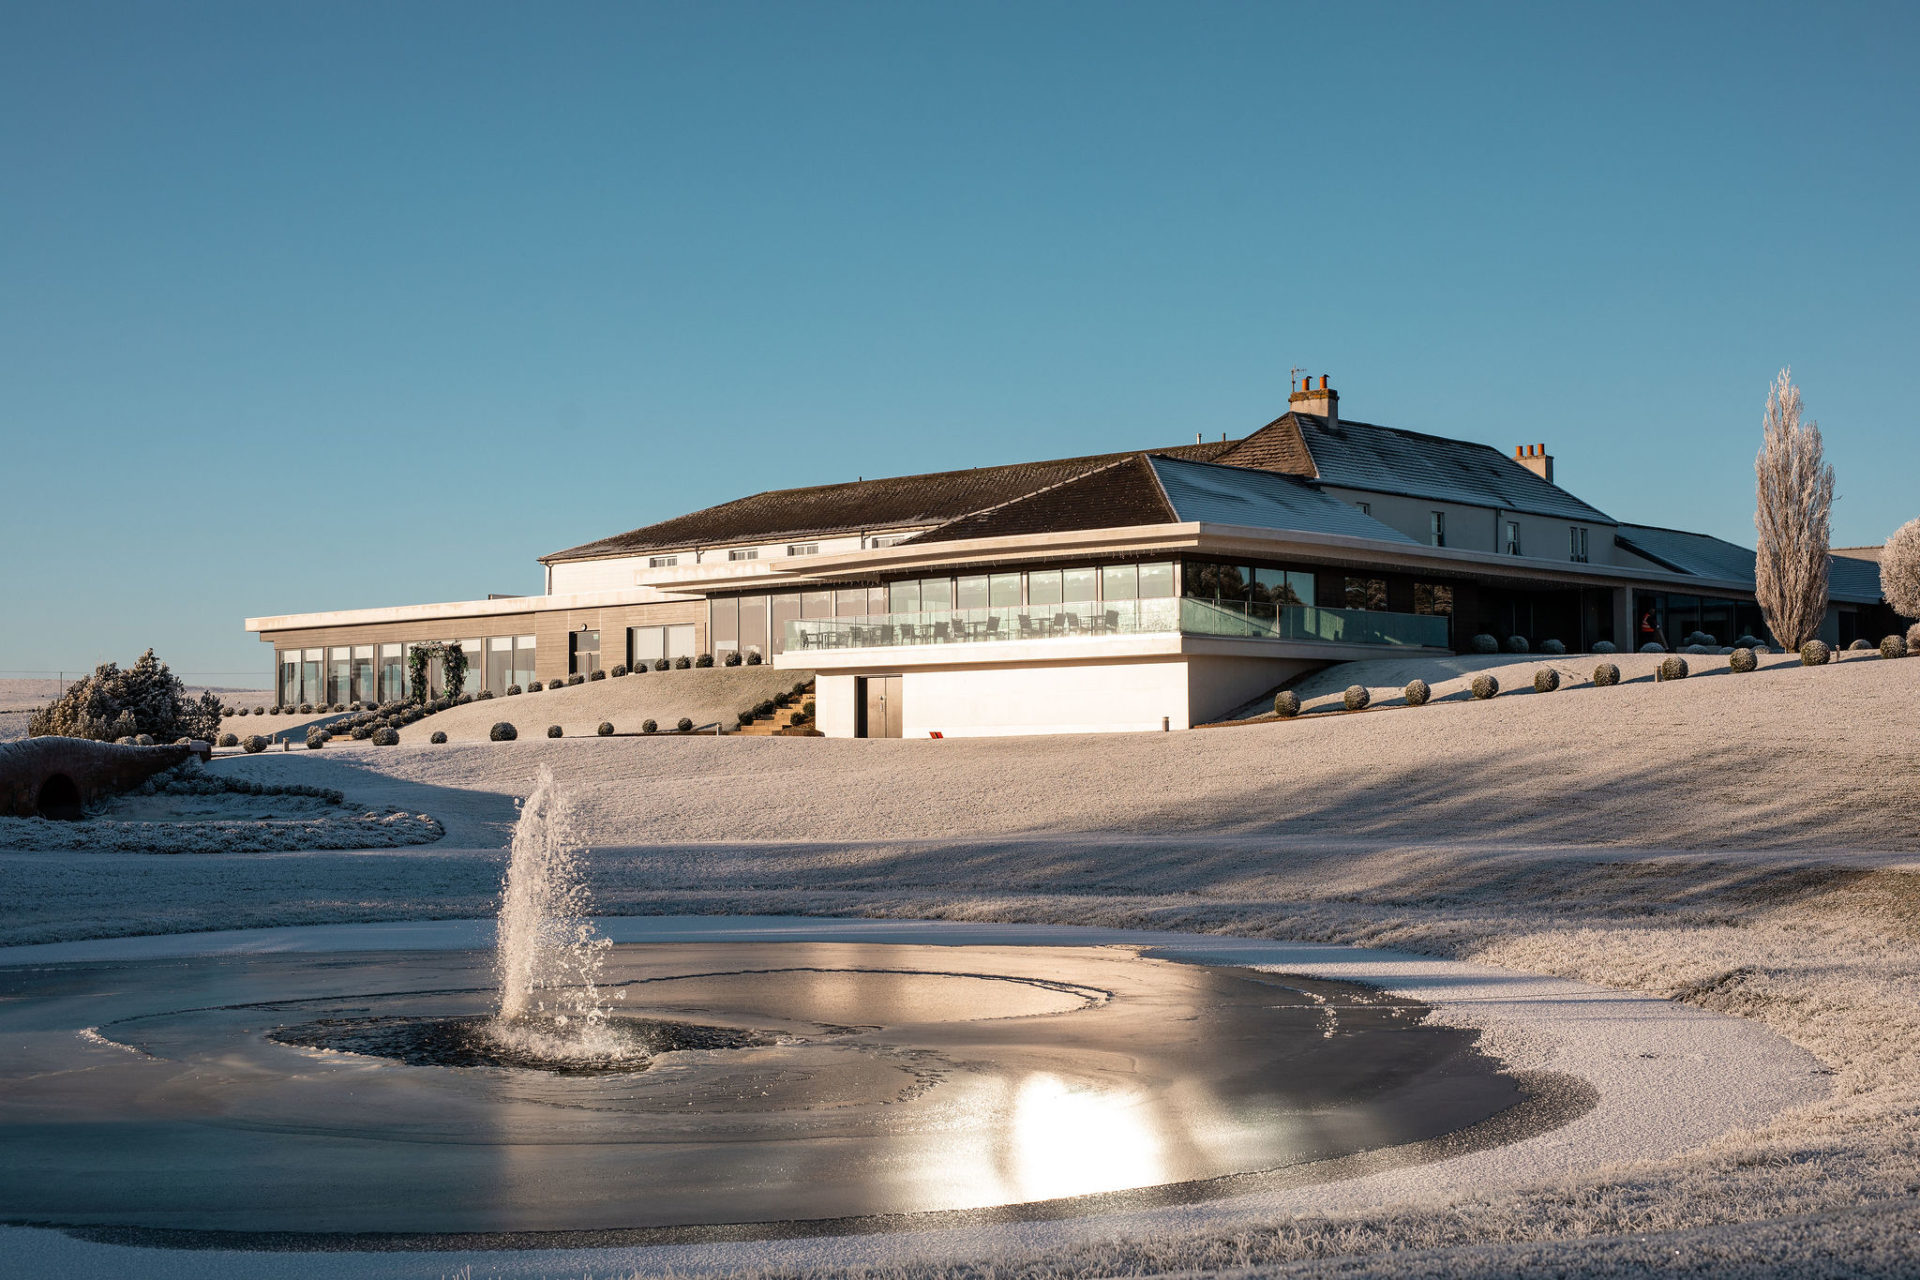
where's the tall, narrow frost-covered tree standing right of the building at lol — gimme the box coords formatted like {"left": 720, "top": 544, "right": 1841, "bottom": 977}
{"left": 1753, "top": 368, "right": 1834, "bottom": 651}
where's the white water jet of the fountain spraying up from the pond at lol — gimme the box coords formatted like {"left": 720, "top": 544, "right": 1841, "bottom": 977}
{"left": 492, "top": 766, "right": 630, "bottom": 1057}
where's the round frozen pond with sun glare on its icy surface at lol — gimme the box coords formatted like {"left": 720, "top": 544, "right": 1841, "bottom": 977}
{"left": 0, "top": 940, "right": 1549, "bottom": 1244}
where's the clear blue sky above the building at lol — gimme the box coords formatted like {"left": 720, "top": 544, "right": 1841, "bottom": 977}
{"left": 0, "top": 0, "right": 1920, "bottom": 677}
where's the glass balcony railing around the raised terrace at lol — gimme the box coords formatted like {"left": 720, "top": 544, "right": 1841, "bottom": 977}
{"left": 787, "top": 599, "right": 1448, "bottom": 652}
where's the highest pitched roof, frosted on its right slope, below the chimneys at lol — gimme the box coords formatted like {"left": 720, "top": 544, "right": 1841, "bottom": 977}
{"left": 1212, "top": 413, "right": 1613, "bottom": 524}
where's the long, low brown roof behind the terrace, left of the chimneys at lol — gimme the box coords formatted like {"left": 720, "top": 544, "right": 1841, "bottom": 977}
{"left": 541, "top": 441, "right": 1233, "bottom": 560}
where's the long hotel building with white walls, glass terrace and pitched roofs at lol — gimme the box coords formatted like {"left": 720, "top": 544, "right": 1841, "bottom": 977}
{"left": 246, "top": 378, "right": 1895, "bottom": 737}
